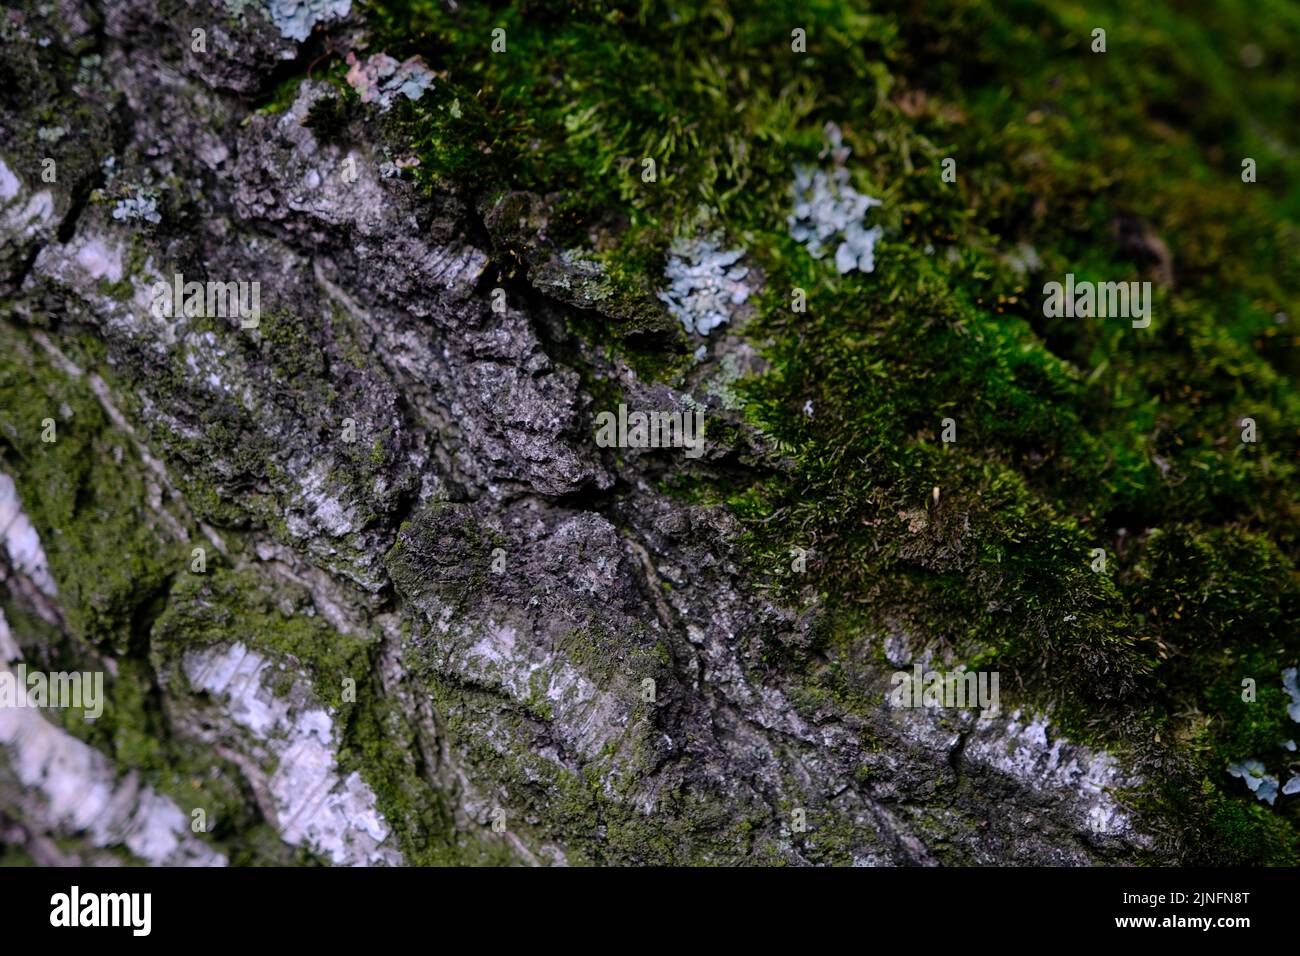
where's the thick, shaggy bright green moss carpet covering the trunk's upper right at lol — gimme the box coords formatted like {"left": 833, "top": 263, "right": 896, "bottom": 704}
{"left": 364, "top": 0, "right": 1300, "bottom": 862}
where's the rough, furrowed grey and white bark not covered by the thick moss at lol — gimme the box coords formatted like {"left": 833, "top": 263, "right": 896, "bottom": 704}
{"left": 0, "top": 0, "right": 1279, "bottom": 865}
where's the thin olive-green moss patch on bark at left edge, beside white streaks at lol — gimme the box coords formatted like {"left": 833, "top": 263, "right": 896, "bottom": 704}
{"left": 0, "top": 326, "right": 312, "bottom": 861}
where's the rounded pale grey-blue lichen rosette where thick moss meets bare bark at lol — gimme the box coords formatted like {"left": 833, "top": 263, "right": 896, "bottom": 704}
{"left": 659, "top": 239, "right": 751, "bottom": 336}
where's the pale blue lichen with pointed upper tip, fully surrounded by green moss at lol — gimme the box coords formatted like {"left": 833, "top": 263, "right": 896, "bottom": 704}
{"left": 787, "top": 124, "right": 881, "bottom": 273}
